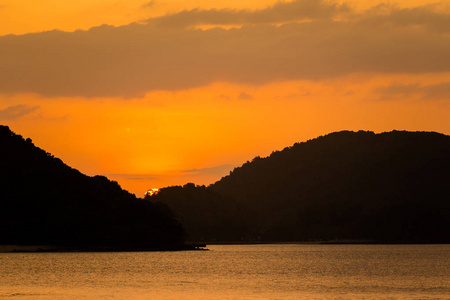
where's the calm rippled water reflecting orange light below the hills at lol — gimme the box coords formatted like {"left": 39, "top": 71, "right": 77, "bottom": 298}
{"left": 0, "top": 245, "right": 450, "bottom": 300}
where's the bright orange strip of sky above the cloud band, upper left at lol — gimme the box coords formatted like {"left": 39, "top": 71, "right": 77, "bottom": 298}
{"left": 0, "top": 0, "right": 276, "bottom": 35}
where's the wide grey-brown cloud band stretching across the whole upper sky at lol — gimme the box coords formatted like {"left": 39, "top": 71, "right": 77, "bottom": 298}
{"left": 0, "top": 0, "right": 450, "bottom": 98}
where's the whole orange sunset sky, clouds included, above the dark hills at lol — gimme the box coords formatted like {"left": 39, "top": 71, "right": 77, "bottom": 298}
{"left": 0, "top": 0, "right": 450, "bottom": 196}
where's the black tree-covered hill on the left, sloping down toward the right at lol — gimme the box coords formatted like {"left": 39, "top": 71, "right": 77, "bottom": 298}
{"left": 0, "top": 126, "right": 184, "bottom": 250}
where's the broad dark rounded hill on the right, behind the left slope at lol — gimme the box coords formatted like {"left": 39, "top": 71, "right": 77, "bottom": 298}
{"left": 150, "top": 131, "right": 450, "bottom": 243}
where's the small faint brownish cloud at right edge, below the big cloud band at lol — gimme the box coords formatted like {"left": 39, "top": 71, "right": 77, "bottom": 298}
{"left": 377, "top": 82, "right": 450, "bottom": 100}
